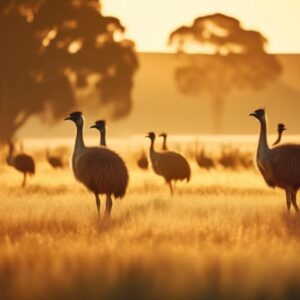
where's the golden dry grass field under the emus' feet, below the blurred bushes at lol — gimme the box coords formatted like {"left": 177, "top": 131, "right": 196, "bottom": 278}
{"left": 0, "top": 139, "right": 300, "bottom": 300}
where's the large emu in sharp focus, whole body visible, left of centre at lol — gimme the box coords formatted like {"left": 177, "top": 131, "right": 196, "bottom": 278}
{"left": 65, "top": 112, "right": 129, "bottom": 216}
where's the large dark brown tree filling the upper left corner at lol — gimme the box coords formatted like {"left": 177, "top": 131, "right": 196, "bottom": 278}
{"left": 0, "top": 0, "right": 138, "bottom": 143}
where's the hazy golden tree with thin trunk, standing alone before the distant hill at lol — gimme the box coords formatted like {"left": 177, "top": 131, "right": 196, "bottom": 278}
{"left": 169, "top": 13, "right": 281, "bottom": 133}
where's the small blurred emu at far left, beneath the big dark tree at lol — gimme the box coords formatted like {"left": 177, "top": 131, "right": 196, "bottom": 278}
{"left": 6, "top": 141, "right": 35, "bottom": 188}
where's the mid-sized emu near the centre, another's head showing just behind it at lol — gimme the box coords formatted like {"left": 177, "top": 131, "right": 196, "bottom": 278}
{"left": 146, "top": 132, "right": 191, "bottom": 196}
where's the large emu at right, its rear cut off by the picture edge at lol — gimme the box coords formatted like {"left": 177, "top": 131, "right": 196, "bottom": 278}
{"left": 250, "top": 109, "right": 300, "bottom": 212}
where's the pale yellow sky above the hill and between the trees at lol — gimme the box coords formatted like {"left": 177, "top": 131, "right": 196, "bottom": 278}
{"left": 102, "top": 0, "right": 300, "bottom": 53}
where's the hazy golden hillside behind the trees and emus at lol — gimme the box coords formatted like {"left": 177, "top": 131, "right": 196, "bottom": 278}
{"left": 18, "top": 53, "right": 300, "bottom": 138}
